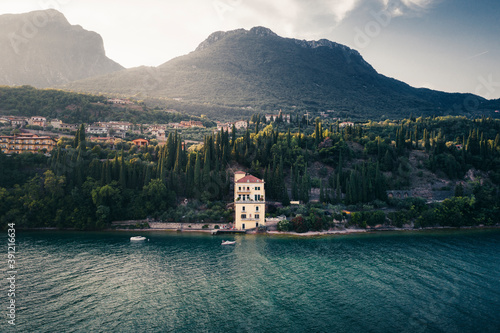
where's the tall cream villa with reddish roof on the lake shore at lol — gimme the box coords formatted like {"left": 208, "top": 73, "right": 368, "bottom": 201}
{"left": 234, "top": 171, "right": 266, "bottom": 230}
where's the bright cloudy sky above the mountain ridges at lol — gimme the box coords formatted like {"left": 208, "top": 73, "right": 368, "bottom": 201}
{"left": 0, "top": 0, "right": 500, "bottom": 99}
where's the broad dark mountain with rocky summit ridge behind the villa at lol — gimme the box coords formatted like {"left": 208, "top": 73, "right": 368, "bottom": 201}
{"left": 61, "top": 27, "right": 496, "bottom": 117}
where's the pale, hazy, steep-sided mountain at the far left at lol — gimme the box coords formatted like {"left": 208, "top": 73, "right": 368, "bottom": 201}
{"left": 0, "top": 9, "right": 123, "bottom": 88}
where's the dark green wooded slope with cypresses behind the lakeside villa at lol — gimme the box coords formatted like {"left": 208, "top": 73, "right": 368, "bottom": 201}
{"left": 0, "top": 115, "right": 500, "bottom": 231}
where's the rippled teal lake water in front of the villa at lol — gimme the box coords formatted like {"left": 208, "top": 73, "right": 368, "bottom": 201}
{"left": 6, "top": 230, "right": 500, "bottom": 332}
